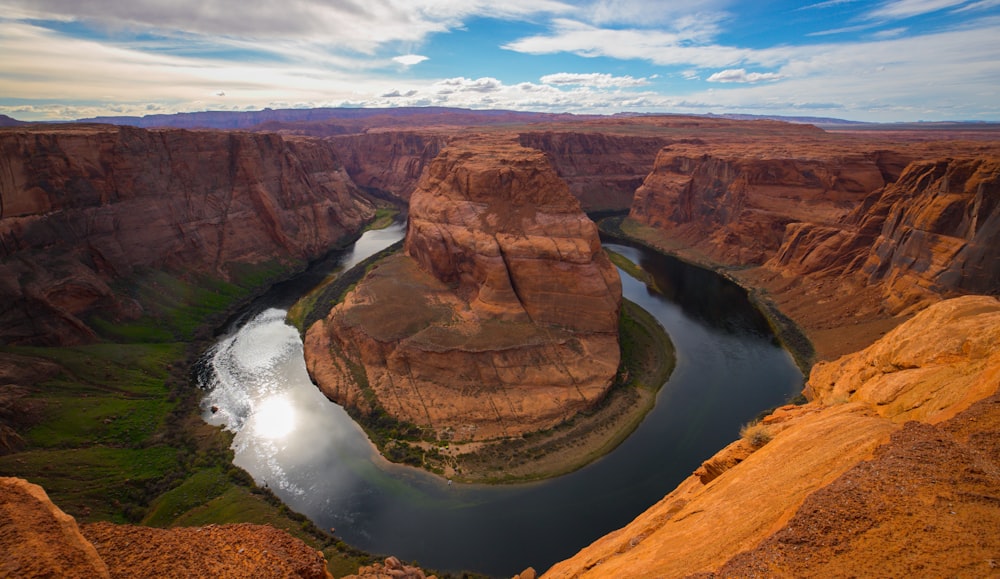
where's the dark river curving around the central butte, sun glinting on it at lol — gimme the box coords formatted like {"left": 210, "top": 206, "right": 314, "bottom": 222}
{"left": 201, "top": 224, "right": 802, "bottom": 577}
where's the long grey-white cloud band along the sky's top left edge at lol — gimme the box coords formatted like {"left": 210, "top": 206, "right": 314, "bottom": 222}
{"left": 3, "top": 0, "right": 573, "bottom": 54}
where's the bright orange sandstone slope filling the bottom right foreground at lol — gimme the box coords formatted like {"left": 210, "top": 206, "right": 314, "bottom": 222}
{"left": 544, "top": 296, "right": 1000, "bottom": 578}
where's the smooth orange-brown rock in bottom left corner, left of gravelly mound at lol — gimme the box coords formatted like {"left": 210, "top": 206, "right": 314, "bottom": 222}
{"left": 0, "top": 477, "right": 110, "bottom": 579}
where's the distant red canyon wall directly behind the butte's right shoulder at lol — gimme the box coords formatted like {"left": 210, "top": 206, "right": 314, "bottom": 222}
{"left": 518, "top": 131, "right": 673, "bottom": 211}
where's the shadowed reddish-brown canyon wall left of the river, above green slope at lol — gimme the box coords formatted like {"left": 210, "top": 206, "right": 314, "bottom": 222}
{"left": 0, "top": 126, "right": 374, "bottom": 343}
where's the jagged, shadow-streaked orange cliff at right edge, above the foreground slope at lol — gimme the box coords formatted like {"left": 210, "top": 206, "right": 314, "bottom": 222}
{"left": 767, "top": 158, "right": 1000, "bottom": 314}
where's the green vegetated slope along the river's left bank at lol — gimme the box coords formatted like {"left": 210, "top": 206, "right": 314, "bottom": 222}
{"left": 0, "top": 221, "right": 406, "bottom": 576}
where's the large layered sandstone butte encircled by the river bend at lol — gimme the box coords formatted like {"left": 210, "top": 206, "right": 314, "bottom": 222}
{"left": 305, "top": 139, "right": 621, "bottom": 441}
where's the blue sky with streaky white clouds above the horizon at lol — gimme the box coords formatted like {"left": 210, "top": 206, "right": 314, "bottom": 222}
{"left": 0, "top": 0, "right": 1000, "bottom": 122}
